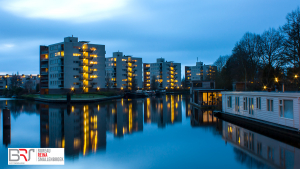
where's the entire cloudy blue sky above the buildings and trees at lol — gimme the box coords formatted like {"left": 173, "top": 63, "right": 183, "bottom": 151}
{"left": 0, "top": 0, "right": 300, "bottom": 74}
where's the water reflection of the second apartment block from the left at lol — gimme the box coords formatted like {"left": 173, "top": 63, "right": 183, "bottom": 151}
{"left": 107, "top": 99, "right": 143, "bottom": 137}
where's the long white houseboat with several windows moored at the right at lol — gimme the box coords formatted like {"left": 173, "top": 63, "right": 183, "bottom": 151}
{"left": 220, "top": 91, "right": 300, "bottom": 133}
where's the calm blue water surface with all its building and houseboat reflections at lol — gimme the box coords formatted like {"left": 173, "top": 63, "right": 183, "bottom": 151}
{"left": 0, "top": 95, "right": 300, "bottom": 168}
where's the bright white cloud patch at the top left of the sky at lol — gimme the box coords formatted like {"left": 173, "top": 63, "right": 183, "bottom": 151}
{"left": 0, "top": 0, "right": 131, "bottom": 22}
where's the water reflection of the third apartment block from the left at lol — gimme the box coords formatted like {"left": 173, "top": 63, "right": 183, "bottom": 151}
{"left": 144, "top": 95, "right": 182, "bottom": 127}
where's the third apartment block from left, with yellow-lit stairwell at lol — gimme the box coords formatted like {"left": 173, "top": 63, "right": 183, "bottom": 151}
{"left": 143, "top": 58, "right": 181, "bottom": 90}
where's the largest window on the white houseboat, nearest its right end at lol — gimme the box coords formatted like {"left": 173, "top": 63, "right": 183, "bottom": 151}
{"left": 279, "top": 100, "right": 294, "bottom": 119}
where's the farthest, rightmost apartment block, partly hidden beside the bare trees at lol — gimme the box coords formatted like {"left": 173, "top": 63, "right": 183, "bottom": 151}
{"left": 185, "top": 62, "right": 217, "bottom": 88}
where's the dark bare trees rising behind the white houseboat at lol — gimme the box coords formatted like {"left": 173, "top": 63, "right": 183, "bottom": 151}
{"left": 214, "top": 7, "right": 300, "bottom": 90}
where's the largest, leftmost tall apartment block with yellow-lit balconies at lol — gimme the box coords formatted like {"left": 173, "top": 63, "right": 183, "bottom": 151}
{"left": 40, "top": 36, "right": 106, "bottom": 94}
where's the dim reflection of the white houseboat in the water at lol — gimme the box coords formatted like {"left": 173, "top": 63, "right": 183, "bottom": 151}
{"left": 222, "top": 121, "right": 300, "bottom": 168}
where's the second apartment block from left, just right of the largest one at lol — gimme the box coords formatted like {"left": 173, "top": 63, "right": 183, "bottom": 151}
{"left": 105, "top": 52, "right": 143, "bottom": 90}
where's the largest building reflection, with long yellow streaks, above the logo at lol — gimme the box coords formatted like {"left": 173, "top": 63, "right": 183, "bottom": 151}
{"left": 40, "top": 104, "right": 106, "bottom": 157}
